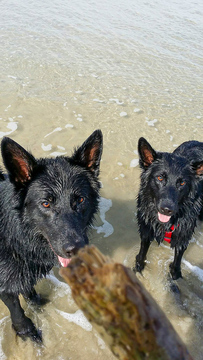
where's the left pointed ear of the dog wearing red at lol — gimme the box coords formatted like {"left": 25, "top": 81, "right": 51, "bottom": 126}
{"left": 138, "top": 137, "right": 157, "bottom": 168}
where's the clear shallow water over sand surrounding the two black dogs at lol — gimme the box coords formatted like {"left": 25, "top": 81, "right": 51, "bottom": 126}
{"left": 0, "top": 0, "right": 203, "bottom": 360}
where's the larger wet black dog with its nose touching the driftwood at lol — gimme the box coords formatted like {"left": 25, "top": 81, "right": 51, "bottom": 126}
{"left": 0, "top": 130, "right": 102, "bottom": 342}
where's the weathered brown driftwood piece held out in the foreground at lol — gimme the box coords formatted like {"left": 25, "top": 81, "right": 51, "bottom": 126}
{"left": 60, "top": 246, "right": 192, "bottom": 360}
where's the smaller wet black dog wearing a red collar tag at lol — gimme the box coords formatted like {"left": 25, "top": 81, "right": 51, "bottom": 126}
{"left": 134, "top": 138, "right": 203, "bottom": 280}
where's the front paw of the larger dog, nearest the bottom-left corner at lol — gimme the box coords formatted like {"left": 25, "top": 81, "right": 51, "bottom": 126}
{"left": 12, "top": 317, "right": 42, "bottom": 344}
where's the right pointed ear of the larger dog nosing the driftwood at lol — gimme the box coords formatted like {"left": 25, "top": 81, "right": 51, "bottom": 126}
{"left": 71, "top": 130, "right": 103, "bottom": 176}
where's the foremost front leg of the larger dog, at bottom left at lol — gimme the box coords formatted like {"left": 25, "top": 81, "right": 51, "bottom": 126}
{"left": 0, "top": 293, "right": 42, "bottom": 343}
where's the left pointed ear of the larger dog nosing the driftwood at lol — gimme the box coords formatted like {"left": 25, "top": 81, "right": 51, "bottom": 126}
{"left": 1, "top": 137, "right": 36, "bottom": 186}
